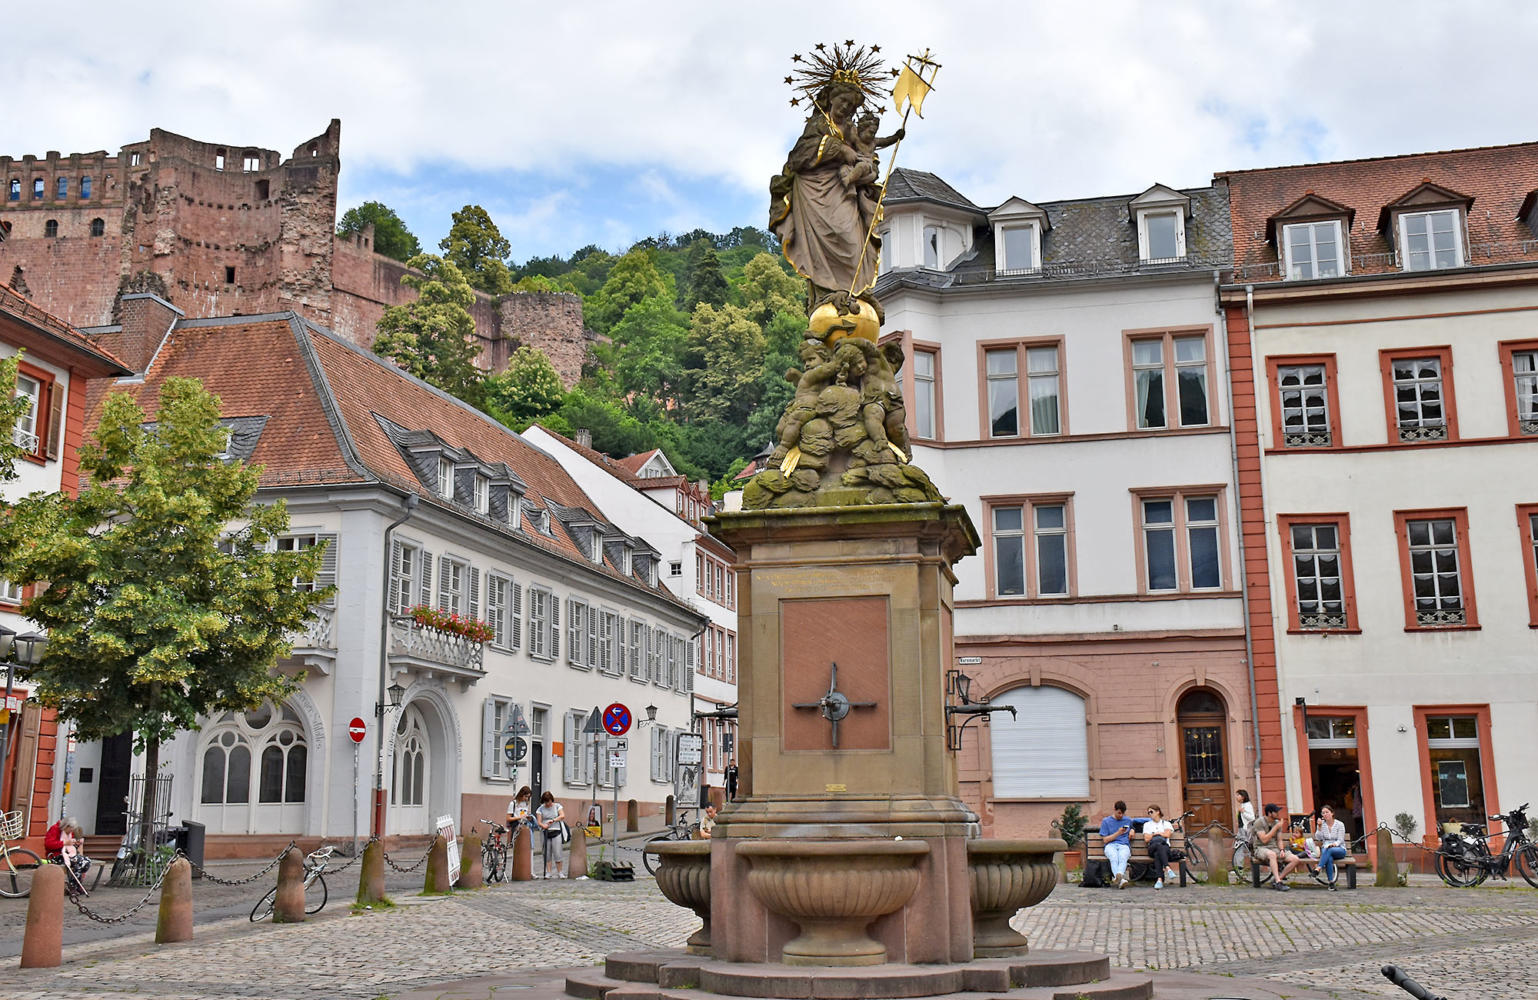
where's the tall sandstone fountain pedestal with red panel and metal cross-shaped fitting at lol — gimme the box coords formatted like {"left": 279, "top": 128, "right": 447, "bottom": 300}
{"left": 711, "top": 503, "right": 978, "bottom": 963}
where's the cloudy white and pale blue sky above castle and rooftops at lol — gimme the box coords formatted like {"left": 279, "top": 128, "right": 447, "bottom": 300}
{"left": 0, "top": 0, "right": 1538, "bottom": 262}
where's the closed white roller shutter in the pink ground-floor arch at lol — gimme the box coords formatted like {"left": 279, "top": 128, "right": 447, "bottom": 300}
{"left": 989, "top": 688, "right": 1089, "bottom": 802}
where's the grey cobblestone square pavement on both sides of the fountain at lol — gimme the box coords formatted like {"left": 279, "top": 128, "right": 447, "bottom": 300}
{"left": 0, "top": 875, "right": 1538, "bottom": 1000}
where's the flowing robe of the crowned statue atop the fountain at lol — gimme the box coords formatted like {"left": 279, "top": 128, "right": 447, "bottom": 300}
{"left": 769, "top": 112, "right": 881, "bottom": 294}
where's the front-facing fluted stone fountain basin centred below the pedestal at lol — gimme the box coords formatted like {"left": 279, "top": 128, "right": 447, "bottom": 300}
{"left": 737, "top": 840, "right": 929, "bottom": 966}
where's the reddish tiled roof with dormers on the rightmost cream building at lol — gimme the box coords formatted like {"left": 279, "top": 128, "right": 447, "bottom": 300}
{"left": 1217, "top": 143, "right": 1538, "bottom": 278}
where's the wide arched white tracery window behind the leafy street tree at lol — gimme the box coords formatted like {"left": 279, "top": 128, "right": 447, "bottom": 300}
{"left": 195, "top": 702, "right": 309, "bottom": 834}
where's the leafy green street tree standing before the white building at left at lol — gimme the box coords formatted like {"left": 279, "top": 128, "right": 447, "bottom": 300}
{"left": 0, "top": 378, "right": 331, "bottom": 861}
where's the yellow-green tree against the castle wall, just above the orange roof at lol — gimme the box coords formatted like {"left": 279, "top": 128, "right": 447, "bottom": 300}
{"left": 374, "top": 254, "right": 484, "bottom": 406}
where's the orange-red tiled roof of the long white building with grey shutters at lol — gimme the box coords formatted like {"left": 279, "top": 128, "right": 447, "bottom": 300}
{"left": 86, "top": 312, "right": 687, "bottom": 608}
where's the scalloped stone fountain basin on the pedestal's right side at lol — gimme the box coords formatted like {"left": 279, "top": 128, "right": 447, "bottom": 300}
{"left": 966, "top": 838, "right": 1067, "bottom": 958}
